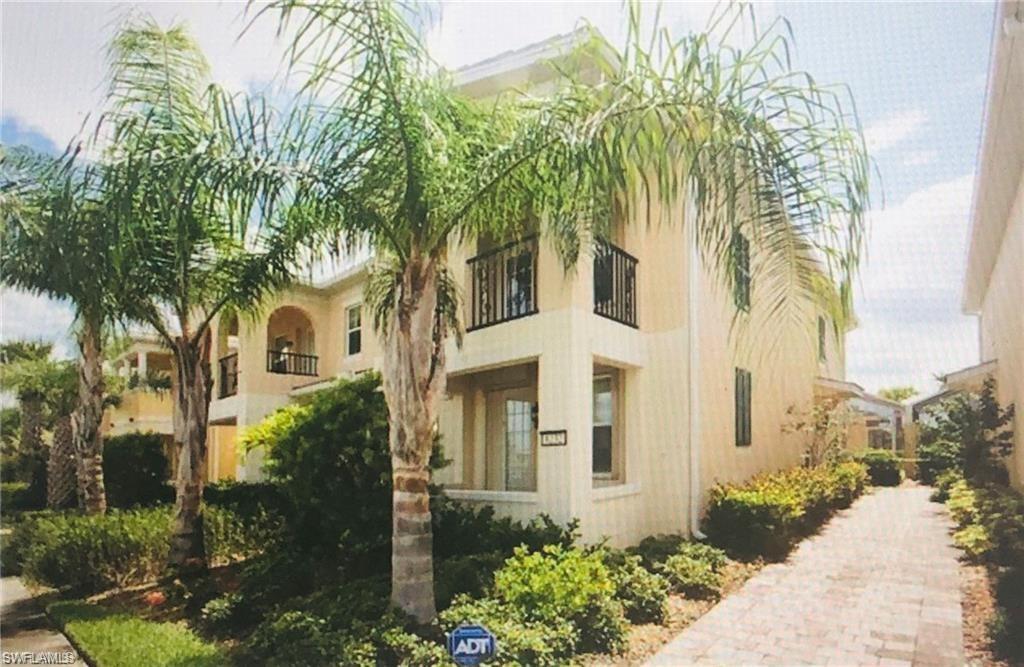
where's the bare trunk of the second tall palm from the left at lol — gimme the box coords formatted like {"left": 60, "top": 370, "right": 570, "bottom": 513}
{"left": 168, "top": 335, "right": 213, "bottom": 571}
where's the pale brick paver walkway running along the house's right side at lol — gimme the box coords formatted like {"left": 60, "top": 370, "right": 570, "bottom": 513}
{"left": 648, "top": 485, "right": 964, "bottom": 667}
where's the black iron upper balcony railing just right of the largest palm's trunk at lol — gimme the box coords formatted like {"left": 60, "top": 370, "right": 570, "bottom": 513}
{"left": 468, "top": 236, "right": 538, "bottom": 331}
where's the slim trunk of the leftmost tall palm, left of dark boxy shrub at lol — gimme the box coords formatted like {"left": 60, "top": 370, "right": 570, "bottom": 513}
{"left": 71, "top": 319, "right": 106, "bottom": 514}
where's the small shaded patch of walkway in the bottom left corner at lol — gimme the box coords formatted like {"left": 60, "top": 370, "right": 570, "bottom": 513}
{"left": 0, "top": 577, "right": 85, "bottom": 665}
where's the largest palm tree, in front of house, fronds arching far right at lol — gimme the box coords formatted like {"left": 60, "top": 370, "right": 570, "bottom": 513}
{"left": 239, "top": 0, "right": 868, "bottom": 622}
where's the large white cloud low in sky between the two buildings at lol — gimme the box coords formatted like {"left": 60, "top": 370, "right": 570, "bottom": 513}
{"left": 847, "top": 174, "right": 978, "bottom": 392}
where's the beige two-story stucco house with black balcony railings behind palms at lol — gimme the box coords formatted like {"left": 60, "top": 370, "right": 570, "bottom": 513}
{"left": 105, "top": 32, "right": 845, "bottom": 544}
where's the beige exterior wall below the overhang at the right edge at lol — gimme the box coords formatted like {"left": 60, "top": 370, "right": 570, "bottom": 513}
{"left": 980, "top": 178, "right": 1024, "bottom": 486}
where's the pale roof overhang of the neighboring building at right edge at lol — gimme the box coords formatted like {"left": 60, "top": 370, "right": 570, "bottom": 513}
{"left": 961, "top": 0, "right": 1024, "bottom": 314}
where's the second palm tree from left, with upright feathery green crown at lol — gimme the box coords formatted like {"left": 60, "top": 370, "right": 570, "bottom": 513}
{"left": 96, "top": 16, "right": 315, "bottom": 570}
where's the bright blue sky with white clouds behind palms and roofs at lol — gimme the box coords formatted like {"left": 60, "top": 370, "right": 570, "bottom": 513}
{"left": 0, "top": 0, "right": 993, "bottom": 394}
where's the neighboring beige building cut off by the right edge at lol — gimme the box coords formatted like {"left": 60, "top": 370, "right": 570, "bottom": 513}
{"left": 943, "top": 0, "right": 1024, "bottom": 486}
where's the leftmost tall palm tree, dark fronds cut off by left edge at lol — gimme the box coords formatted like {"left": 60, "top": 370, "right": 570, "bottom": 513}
{"left": 0, "top": 149, "right": 114, "bottom": 513}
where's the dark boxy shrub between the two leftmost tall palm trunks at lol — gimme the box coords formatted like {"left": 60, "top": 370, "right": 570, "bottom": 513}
{"left": 103, "top": 432, "right": 174, "bottom": 507}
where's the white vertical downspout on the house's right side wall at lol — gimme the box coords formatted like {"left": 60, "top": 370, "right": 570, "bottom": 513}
{"left": 685, "top": 198, "right": 708, "bottom": 540}
